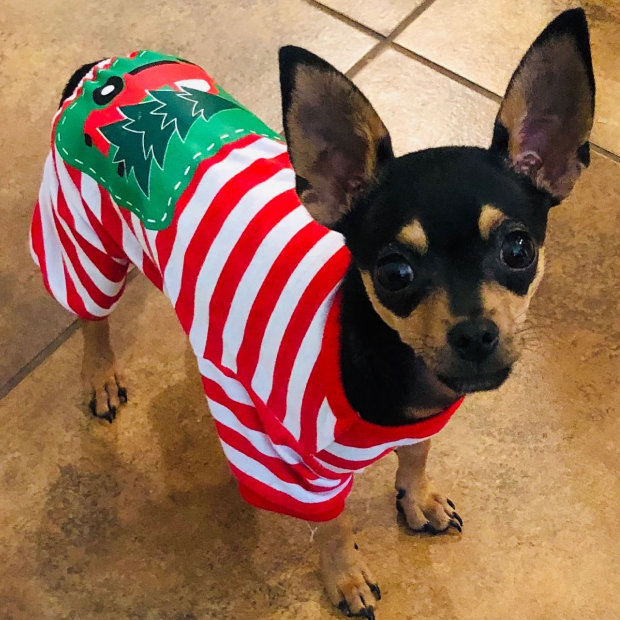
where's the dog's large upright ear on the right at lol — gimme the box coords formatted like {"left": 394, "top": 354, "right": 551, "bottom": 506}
{"left": 491, "top": 9, "right": 595, "bottom": 204}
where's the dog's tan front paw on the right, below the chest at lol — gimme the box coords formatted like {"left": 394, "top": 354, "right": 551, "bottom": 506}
{"left": 396, "top": 484, "right": 463, "bottom": 534}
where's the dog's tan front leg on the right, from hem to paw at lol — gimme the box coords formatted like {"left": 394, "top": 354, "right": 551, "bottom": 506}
{"left": 396, "top": 439, "right": 463, "bottom": 534}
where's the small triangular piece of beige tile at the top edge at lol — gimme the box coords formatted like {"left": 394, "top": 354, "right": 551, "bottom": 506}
{"left": 321, "top": 0, "right": 424, "bottom": 35}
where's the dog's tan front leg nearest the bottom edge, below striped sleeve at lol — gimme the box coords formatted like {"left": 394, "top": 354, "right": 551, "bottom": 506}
{"left": 317, "top": 511, "right": 381, "bottom": 620}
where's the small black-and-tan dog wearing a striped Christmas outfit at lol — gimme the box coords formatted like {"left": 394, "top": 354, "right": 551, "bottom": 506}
{"left": 31, "top": 9, "right": 595, "bottom": 618}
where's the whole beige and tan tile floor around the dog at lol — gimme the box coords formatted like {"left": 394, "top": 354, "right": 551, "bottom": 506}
{"left": 0, "top": 0, "right": 620, "bottom": 620}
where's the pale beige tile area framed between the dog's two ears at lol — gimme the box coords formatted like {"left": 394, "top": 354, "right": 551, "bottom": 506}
{"left": 355, "top": 49, "right": 497, "bottom": 154}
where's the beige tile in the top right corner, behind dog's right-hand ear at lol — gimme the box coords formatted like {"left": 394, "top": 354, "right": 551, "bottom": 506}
{"left": 397, "top": 0, "right": 620, "bottom": 154}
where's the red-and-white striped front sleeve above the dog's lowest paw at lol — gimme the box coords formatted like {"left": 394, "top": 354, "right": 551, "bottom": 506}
{"left": 199, "top": 359, "right": 353, "bottom": 521}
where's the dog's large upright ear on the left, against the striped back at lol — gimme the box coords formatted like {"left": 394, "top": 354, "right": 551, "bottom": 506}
{"left": 280, "top": 46, "right": 393, "bottom": 227}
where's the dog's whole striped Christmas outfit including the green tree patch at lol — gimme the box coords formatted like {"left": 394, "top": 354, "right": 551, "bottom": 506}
{"left": 30, "top": 51, "right": 460, "bottom": 521}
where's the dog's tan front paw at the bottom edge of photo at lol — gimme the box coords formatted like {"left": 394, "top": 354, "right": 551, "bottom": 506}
{"left": 321, "top": 545, "right": 381, "bottom": 620}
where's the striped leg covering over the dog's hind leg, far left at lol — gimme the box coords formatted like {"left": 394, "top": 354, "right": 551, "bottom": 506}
{"left": 30, "top": 152, "right": 128, "bottom": 320}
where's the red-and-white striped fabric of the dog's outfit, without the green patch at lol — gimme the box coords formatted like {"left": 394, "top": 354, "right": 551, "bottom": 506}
{"left": 31, "top": 53, "right": 460, "bottom": 521}
